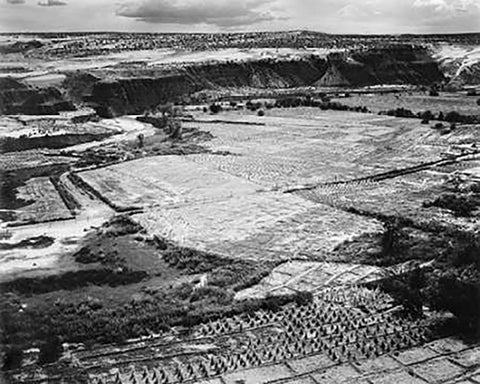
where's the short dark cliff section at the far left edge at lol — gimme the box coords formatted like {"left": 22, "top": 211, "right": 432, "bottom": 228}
{"left": 0, "top": 77, "right": 75, "bottom": 115}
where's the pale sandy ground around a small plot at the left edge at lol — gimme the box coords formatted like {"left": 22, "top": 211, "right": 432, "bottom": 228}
{"left": 0, "top": 174, "right": 114, "bottom": 282}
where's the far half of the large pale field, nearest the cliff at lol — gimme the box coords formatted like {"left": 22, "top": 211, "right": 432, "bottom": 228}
{"left": 185, "top": 108, "right": 458, "bottom": 188}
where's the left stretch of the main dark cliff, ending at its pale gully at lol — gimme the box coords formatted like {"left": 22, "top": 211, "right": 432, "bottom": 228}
{"left": 88, "top": 58, "right": 327, "bottom": 117}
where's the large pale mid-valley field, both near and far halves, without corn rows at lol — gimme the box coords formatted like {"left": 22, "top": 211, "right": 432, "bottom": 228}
{"left": 78, "top": 108, "right": 475, "bottom": 260}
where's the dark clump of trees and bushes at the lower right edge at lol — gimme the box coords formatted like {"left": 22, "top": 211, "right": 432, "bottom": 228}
{"left": 344, "top": 219, "right": 480, "bottom": 338}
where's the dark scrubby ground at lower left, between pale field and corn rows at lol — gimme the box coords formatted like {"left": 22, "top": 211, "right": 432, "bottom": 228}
{"left": 0, "top": 216, "right": 280, "bottom": 356}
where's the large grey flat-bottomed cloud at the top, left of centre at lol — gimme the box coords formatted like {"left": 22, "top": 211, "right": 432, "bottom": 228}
{"left": 116, "top": 0, "right": 275, "bottom": 27}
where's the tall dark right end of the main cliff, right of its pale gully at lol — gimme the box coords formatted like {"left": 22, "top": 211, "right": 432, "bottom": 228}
{"left": 316, "top": 45, "right": 444, "bottom": 86}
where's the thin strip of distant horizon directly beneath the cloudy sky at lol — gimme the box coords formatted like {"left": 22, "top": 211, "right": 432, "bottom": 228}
{"left": 0, "top": 29, "right": 480, "bottom": 36}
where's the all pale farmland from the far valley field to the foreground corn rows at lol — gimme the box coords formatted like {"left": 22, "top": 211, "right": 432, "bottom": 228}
{"left": 3, "top": 108, "right": 480, "bottom": 384}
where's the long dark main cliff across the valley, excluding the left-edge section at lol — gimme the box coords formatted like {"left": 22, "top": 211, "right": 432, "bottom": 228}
{"left": 83, "top": 45, "right": 444, "bottom": 117}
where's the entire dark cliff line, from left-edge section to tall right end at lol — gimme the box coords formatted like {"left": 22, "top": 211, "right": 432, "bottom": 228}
{"left": 0, "top": 45, "right": 450, "bottom": 117}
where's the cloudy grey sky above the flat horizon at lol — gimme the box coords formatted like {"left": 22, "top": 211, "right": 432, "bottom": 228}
{"left": 0, "top": 0, "right": 480, "bottom": 33}
